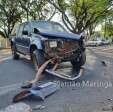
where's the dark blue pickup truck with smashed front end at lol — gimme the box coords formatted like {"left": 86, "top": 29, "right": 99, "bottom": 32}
{"left": 10, "top": 21, "right": 86, "bottom": 68}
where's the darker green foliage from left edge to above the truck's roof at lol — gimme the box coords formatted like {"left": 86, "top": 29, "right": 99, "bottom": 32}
{"left": 0, "top": 0, "right": 56, "bottom": 38}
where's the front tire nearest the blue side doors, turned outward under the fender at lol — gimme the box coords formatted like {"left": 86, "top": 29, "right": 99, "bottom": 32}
{"left": 31, "top": 49, "right": 45, "bottom": 71}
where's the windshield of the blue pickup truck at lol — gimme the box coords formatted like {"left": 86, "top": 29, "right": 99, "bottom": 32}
{"left": 32, "top": 22, "right": 67, "bottom": 32}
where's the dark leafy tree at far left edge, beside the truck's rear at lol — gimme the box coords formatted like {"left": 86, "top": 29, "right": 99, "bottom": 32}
{"left": 0, "top": 0, "right": 22, "bottom": 38}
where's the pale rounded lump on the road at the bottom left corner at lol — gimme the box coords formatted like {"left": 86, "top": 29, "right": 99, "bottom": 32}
{"left": 0, "top": 102, "right": 32, "bottom": 112}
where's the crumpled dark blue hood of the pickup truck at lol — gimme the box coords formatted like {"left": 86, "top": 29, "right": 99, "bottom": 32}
{"left": 39, "top": 32, "right": 81, "bottom": 40}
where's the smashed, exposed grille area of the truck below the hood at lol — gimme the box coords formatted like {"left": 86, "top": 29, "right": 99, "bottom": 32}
{"left": 44, "top": 40, "right": 81, "bottom": 61}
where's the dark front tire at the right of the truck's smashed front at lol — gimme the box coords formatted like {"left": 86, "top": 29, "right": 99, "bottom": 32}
{"left": 71, "top": 52, "right": 86, "bottom": 69}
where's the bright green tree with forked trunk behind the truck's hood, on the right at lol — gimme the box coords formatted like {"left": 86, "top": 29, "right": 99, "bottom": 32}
{"left": 47, "top": 0, "right": 112, "bottom": 34}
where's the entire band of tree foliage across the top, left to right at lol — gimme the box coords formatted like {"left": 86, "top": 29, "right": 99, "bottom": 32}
{"left": 0, "top": 0, "right": 113, "bottom": 38}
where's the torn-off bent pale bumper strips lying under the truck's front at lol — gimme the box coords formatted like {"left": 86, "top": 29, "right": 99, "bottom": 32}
{"left": 21, "top": 58, "right": 84, "bottom": 88}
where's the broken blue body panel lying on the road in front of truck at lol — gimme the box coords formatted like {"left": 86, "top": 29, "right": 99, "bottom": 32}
{"left": 13, "top": 82, "right": 59, "bottom": 102}
